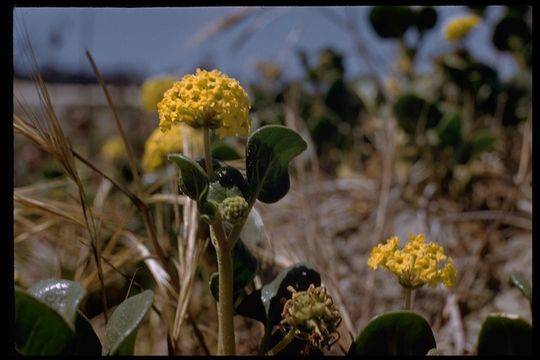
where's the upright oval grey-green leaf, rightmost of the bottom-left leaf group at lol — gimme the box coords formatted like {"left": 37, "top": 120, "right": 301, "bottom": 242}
{"left": 102, "top": 290, "right": 154, "bottom": 355}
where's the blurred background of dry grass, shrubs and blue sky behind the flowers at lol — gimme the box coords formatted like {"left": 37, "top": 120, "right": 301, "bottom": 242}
{"left": 13, "top": 6, "right": 532, "bottom": 354}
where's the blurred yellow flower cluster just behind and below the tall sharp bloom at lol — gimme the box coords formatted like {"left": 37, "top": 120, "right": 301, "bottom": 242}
{"left": 142, "top": 124, "right": 202, "bottom": 172}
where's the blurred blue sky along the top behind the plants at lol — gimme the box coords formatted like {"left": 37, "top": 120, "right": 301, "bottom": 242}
{"left": 14, "top": 6, "right": 513, "bottom": 80}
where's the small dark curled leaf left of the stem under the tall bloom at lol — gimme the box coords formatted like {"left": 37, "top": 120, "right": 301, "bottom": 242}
{"left": 168, "top": 154, "right": 209, "bottom": 204}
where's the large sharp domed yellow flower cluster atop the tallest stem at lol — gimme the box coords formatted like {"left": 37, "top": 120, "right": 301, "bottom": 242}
{"left": 158, "top": 69, "right": 251, "bottom": 138}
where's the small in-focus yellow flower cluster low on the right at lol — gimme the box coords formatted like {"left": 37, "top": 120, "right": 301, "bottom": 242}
{"left": 368, "top": 234, "right": 456, "bottom": 289}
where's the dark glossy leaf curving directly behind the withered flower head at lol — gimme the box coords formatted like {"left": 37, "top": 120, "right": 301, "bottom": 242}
{"left": 261, "top": 263, "right": 321, "bottom": 325}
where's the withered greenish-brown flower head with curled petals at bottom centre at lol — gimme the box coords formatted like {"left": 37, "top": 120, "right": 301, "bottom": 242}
{"left": 280, "top": 284, "right": 341, "bottom": 349}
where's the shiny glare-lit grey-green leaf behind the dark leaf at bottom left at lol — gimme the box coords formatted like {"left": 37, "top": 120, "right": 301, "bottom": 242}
{"left": 27, "top": 279, "right": 86, "bottom": 331}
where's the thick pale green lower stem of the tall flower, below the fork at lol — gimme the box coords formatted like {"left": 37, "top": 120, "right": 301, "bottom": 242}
{"left": 216, "top": 242, "right": 236, "bottom": 355}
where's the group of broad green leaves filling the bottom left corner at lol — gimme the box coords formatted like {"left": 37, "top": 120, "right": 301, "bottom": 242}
{"left": 15, "top": 279, "right": 153, "bottom": 356}
